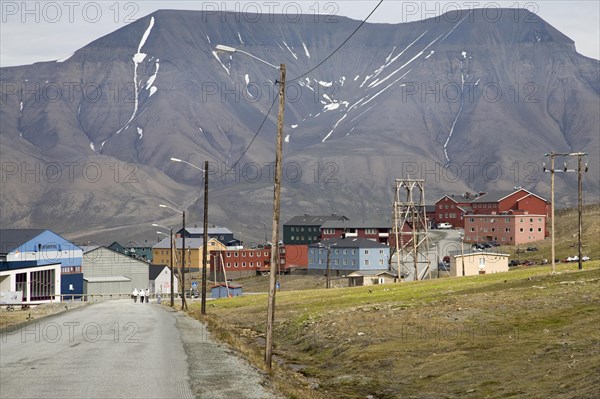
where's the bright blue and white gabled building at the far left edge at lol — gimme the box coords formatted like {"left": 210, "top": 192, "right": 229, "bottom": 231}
{"left": 0, "top": 229, "right": 83, "bottom": 298}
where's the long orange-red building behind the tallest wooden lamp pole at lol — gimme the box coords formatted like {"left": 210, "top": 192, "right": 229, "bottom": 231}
{"left": 210, "top": 245, "right": 308, "bottom": 281}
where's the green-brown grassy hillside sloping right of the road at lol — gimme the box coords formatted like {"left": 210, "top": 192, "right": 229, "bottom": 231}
{"left": 190, "top": 205, "right": 600, "bottom": 398}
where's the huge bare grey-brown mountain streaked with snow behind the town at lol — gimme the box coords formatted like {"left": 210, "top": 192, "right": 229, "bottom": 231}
{"left": 0, "top": 9, "right": 600, "bottom": 241}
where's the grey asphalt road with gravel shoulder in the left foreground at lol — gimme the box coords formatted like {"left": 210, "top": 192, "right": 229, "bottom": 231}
{"left": 0, "top": 300, "right": 275, "bottom": 398}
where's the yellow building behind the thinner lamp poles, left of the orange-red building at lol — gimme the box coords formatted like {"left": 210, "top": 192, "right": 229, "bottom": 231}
{"left": 152, "top": 237, "right": 227, "bottom": 269}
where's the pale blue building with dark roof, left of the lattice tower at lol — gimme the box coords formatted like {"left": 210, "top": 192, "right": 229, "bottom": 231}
{"left": 308, "top": 238, "right": 390, "bottom": 275}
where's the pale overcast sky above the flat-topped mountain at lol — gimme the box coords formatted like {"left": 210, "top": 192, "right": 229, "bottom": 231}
{"left": 0, "top": 0, "right": 600, "bottom": 66}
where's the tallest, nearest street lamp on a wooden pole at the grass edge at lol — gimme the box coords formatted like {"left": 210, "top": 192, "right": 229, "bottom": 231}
{"left": 216, "top": 44, "right": 286, "bottom": 370}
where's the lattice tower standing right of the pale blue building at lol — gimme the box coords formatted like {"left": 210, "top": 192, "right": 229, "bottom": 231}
{"left": 392, "top": 178, "right": 431, "bottom": 281}
